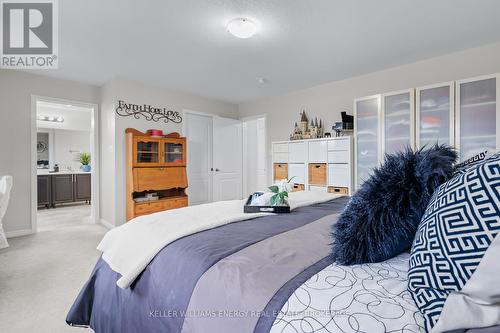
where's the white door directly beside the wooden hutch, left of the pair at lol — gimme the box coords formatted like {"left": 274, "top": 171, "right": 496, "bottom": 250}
{"left": 184, "top": 113, "right": 212, "bottom": 205}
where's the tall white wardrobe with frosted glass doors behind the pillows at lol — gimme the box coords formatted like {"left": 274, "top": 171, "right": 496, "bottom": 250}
{"left": 354, "top": 74, "right": 500, "bottom": 188}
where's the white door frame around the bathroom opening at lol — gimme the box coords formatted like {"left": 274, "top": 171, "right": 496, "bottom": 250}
{"left": 30, "top": 95, "right": 100, "bottom": 234}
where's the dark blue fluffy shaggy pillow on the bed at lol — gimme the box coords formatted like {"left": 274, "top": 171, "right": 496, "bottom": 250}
{"left": 331, "top": 145, "right": 457, "bottom": 265}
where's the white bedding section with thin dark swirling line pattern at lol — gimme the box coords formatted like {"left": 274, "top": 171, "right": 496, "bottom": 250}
{"left": 271, "top": 253, "right": 425, "bottom": 333}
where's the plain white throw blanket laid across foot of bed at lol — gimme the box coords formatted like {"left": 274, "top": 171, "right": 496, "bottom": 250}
{"left": 97, "top": 191, "right": 339, "bottom": 288}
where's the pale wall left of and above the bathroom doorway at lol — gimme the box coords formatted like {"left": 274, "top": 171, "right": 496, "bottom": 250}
{"left": 0, "top": 69, "right": 100, "bottom": 235}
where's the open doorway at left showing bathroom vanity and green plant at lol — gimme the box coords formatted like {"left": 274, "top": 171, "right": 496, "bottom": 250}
{"left": 31, "top": 96, "right": 99, "bottom": 233}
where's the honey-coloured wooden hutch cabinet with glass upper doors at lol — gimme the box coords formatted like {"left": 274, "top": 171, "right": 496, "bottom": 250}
{"left": 125, "top": 128, "right": 188, "bottom": 221}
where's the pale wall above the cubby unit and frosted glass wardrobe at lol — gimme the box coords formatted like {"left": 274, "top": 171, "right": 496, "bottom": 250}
{"left": 238, "top": 43, "right": 500, "bottom": 181}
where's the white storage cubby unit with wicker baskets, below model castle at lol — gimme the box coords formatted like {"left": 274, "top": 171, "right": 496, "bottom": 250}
{"left": 272, "top": 136, "right": 354, "bottom": 195}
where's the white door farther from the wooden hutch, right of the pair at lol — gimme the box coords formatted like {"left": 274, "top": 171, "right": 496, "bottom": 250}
{"left": 213, "top": 117, "right": 243, "bottom": 201}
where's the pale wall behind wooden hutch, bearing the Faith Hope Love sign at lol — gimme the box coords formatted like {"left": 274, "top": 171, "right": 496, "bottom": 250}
{"left": 101, "top": 79, "right": 237, "bottom": 225}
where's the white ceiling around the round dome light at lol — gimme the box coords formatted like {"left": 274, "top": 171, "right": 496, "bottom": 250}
{"left": 33, "top": 0, "right": 500, "bottom": 102}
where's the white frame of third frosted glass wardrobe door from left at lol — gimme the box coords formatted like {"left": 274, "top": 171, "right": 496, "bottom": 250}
{"left": 415, "top": 81, "right": 455, "bottom": 149}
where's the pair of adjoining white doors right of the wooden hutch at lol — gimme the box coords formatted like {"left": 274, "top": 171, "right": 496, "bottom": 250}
{"left": 183, "top": 111, "right": 243, "bottom": 205}
